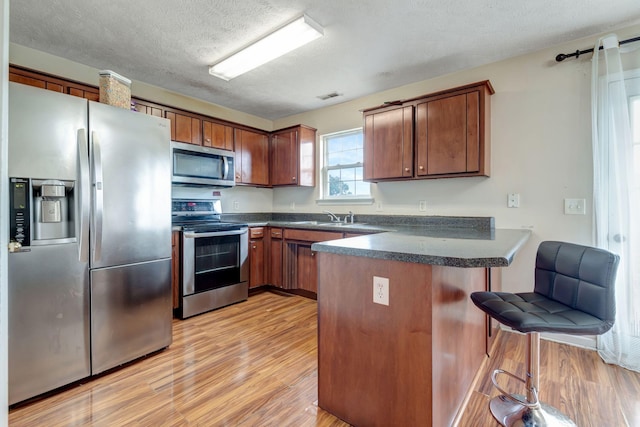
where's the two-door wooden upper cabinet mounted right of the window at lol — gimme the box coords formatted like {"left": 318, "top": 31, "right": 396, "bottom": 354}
{"left": 364, "top": 81, "right": 494, "bottom": 181}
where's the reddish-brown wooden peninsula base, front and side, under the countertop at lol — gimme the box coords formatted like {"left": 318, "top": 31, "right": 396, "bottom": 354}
{"left": 316, "top": 252, "right": 486, "bottom": 426}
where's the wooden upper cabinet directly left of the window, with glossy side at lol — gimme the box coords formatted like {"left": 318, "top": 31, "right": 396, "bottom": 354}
{"left": 270, "top": 125, "right": 316, "bottom": 187}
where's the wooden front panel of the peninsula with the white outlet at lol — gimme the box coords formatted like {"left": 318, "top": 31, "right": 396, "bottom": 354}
{"left": 317, "top": 253, "right": 432, "bottom": 427}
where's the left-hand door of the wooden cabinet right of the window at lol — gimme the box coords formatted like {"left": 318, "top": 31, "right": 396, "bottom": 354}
{"left": 364, "top": 106, "right": 413, "bottom": 181}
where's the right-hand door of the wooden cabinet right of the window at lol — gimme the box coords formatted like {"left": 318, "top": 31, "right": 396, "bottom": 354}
{"left": 416, "top": 91, "right": 480, "bottom": 176}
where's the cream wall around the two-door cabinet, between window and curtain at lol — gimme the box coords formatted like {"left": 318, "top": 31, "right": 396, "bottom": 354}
{"left": 273, "top": 25, "right": 640, "bottom": 304}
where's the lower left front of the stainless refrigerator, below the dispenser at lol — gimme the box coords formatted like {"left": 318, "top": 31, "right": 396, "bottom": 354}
{"left": 8, "top": 243, "right": 90, "bottom": 404}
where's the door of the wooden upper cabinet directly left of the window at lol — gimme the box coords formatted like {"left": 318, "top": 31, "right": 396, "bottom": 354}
{"left": 271, "top": 130, "right": 298, "bottom": 185}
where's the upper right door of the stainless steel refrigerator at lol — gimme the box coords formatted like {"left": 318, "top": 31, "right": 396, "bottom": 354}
{"left": 89, "top": 102, "right": 171, "bottom": 268}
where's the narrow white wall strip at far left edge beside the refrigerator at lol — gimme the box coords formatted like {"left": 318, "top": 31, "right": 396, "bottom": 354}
{"left": 0, "top": 0, "right": 9, "bottom": 426}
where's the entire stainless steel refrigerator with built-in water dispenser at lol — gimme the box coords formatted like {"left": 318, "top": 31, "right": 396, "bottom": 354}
{"left": 8, "top": 83, "right": 172, "bottom": 404}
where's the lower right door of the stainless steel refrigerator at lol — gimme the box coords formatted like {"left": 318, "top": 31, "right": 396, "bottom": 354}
{"left": 91, "top": 259, "right": 173, "bottom": 374}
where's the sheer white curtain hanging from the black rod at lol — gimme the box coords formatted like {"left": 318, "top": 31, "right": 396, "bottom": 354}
{"left": 591, "top": 35, "right": 640, "bottom": 372}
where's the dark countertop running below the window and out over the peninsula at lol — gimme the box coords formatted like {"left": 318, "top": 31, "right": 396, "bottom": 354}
{"left": 181, "top": 213, "right": 531, "bottom": 267}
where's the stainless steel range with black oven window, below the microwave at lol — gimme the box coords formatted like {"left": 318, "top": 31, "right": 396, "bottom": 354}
{"left": 172, "top": 191, "right": 249, "bottom": 319}
